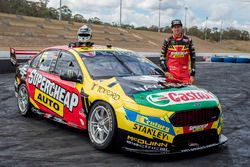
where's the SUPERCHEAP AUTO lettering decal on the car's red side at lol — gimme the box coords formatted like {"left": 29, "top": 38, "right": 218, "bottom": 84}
{"left": 28, "top": 70, "right": 79, "bottom": 116}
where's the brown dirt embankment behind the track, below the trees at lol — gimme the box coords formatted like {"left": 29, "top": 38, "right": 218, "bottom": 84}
{"left": 0, "top": 13, "right": 250, "bottom": 53}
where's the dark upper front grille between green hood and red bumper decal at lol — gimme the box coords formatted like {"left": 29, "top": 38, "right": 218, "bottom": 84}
{"left": 170, "top": 107, "right": 220, "bottom": 127}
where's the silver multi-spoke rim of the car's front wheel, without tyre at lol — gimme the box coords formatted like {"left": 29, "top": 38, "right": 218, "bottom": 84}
{"left": 89, "top": 106, "right": 112, "bottom": 144}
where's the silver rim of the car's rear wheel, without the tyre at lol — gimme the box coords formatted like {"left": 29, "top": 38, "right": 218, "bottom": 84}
{"left": 18, "top": 86, "right": 28, "bottom": 114}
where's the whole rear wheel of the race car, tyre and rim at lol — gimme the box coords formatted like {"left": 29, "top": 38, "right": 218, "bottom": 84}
{"left": 17, "top": 84, "right": 31, "bottom": 116}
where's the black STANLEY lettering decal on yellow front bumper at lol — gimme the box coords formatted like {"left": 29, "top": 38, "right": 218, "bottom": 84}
{"left": 133, "top": 123, "right": 168, "bottom": 141}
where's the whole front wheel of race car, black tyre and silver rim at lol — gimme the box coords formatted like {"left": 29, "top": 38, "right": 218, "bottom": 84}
{"left": 88, "top": 101, "right": 117, "bottom": 151}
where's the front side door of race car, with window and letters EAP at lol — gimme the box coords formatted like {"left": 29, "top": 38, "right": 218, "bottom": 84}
{"left": 51, "top": 51, "right": 86, "bottom": 129}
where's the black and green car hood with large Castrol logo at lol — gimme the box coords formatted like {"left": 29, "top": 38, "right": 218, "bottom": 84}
{"left": 116, "top": 76, "right": 219, "bottom": 111}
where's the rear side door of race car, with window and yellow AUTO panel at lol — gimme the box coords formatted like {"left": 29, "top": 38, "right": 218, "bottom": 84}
{"left": 26, "top": 50, "right": 60, "bottom": 116}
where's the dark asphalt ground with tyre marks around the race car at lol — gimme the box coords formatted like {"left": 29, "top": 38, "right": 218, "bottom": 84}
{"left": 0, "top": 63, "right": 250, "bottom": 167}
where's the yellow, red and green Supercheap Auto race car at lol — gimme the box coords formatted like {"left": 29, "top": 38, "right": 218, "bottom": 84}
{"left": 10, "top": 43, "right": 227, "bottom": 154}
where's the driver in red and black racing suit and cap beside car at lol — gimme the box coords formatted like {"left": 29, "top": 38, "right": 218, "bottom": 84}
{"left": 160, "top": 19, "right": 195, "bottom": 84}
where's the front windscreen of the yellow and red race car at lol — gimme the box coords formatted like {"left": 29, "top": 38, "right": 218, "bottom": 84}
{"left": 80, "top": 51, "right": 164, "bottom": 79}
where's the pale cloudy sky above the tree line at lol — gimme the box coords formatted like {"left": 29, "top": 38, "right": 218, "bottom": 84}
{"left": 39, "top": 0, "right": 250, "bottom": 31}
